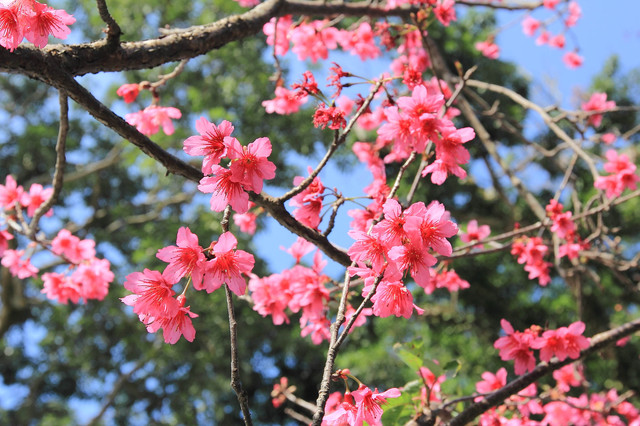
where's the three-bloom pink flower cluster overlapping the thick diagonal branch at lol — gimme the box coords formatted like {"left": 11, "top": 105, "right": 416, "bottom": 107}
{"left": 184, "top": 117, "right": 276, "bottom": 213}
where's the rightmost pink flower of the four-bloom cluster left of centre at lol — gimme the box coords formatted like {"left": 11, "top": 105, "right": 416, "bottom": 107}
{"left": 199, "top": 232, "right": 255, "bottom": 296}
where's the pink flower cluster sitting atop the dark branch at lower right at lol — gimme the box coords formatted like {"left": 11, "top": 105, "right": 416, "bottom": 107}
{"left": 493, "top": 319, "right": 589, "bottom": 375}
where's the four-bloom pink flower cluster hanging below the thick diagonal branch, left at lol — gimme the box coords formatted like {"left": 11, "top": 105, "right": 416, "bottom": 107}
{"left": 121, "top": 227, "right": 255, "bottom": 344}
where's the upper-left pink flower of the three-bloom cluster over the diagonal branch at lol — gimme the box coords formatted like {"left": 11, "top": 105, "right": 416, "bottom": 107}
{"left": 183, "top": 117, "right": 233, "bottom": 175}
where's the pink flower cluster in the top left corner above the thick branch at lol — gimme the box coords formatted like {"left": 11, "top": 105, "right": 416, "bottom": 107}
{"left": 0, "top": 0, "right": 76, "bottom": 52}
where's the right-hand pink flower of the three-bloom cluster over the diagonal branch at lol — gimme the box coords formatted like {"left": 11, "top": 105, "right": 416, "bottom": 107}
{"left": 225, "top": 137, "right": 276, "bottom": 194}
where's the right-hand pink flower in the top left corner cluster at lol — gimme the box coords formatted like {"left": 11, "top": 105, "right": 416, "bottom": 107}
{"left": 24, "top": 1, "right": 76, "bottom": 48}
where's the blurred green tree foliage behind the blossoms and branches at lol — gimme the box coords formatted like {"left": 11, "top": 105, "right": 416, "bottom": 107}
{"left": 0, "top": 0, "right": 640, "bottom": 425}
